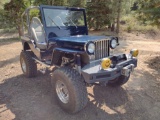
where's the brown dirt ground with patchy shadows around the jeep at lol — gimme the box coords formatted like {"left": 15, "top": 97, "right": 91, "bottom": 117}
{"left": 0, "top": 34, "right": 160, "bottom": 120}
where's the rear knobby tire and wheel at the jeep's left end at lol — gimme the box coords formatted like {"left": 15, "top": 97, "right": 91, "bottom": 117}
{"left": 20, "top": 51, "right": 37, "bottom": 78}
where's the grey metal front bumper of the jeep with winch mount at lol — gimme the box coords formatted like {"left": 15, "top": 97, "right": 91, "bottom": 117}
{"left": 81, "top": 54, "right": 137, "bottom": 84}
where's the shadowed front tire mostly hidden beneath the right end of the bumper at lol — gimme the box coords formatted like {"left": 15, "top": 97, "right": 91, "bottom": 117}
{"left": 107, "top": 75, "right": 130, "bottom": 87}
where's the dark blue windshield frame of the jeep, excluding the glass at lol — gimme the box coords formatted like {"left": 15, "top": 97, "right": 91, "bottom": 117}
{"left": 40, "top": 5, "right": 88, "bottom": 41}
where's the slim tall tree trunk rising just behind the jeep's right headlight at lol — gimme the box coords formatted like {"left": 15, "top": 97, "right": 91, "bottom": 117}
{"left": 116, "top": 0, "right": 122, "bottom": 34}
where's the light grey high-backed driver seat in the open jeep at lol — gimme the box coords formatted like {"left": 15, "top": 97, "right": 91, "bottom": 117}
{"left": 30, "top": 17, "right": 47, "bottom": 49}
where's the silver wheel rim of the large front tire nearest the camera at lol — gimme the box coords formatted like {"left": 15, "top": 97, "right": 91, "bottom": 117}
{"left": 56, "top": 80, "right": 69, "bottom": 104}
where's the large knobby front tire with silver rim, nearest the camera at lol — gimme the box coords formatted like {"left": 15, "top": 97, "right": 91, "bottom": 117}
{"left": 51, "top": 67, "right": 88, "bottom": 114}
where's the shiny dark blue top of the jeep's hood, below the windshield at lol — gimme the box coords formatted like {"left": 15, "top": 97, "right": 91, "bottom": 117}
{"left": 49, "top": 35, "right": 111, "bottom": 43}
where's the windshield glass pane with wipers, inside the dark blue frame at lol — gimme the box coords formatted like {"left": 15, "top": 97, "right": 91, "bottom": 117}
{"left": 43, "top": 8, "right": 85, "bottom": 28}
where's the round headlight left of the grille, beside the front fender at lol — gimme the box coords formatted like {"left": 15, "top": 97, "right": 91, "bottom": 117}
{"left": 85, "top": 42, "right": 95, "bottom": 55}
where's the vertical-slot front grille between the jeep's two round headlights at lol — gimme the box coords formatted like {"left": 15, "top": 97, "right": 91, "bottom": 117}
{"left": 95, "top": 40, "right": 109, "bottom": 60}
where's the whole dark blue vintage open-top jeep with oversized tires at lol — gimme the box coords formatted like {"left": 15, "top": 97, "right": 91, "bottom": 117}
{"left": 20, "top": 5, "right": 138, "bottom": 113}
